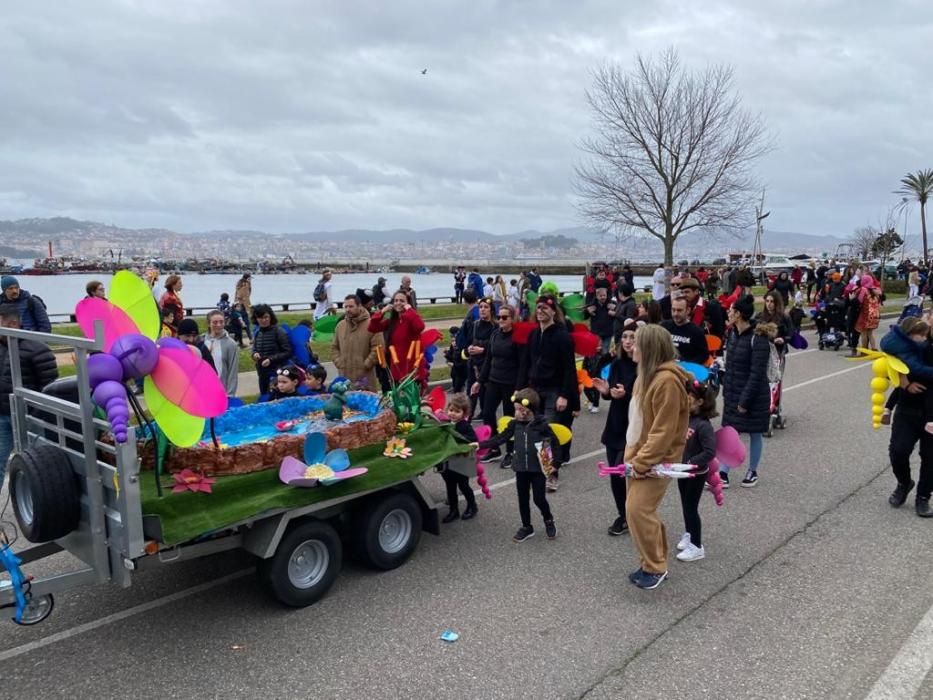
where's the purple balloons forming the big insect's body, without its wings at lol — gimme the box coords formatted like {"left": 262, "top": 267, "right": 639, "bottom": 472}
{"left": 87, "top": 333, "right": 158, "bottom": 443}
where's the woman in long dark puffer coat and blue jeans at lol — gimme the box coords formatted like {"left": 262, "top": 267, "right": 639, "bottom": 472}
{"left": 719, "top": 295, "right": 771, "bottom": 488}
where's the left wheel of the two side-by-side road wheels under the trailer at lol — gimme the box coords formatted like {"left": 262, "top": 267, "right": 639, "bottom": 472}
{"left": 256, "top": 520, "right": 343, "bottom": 608}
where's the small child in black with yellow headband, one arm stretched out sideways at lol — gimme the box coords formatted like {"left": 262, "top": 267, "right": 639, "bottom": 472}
{"left": 479, "top": 389, "right": 560, "bottom": 542}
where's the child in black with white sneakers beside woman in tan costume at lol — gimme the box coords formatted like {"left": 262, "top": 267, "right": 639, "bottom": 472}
{"left": 677, "top": 380, "right": 719, "bottom": 561}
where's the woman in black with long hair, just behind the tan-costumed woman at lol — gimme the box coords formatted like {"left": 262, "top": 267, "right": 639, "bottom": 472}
{"left": 593, "top": 323, "right": 638, "bottom": 536}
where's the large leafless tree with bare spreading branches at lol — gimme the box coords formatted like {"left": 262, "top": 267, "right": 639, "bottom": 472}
{"left": 574, "top": 50, "right": 770, "bottom": 264}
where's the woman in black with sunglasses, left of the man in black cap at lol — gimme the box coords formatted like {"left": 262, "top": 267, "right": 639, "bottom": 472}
{"left": 470, "top": 304, "right": 522, "bottom": 469}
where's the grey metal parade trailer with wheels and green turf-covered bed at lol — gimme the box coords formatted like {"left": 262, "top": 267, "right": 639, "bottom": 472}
{"left": 0, "top": 328, "right": 460, "bottom": 625}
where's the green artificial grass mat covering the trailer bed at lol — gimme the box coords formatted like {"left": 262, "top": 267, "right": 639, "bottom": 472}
{"left": 141, "top": 425, "right": 469, "bottom": 545}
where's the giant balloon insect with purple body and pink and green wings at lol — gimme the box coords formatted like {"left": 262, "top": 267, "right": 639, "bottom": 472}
{"left": 75, "top": 270, "right": 227, "bottom": 447}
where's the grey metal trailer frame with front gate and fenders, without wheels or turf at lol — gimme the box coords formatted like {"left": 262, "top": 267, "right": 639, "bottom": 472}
{"left": 0, "top": 322, "right": 440, "bottom": 621}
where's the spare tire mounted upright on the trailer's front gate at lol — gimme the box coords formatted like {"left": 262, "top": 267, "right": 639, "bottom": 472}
{"left": 10, "top": 445, "right": 81, "bottom": 542}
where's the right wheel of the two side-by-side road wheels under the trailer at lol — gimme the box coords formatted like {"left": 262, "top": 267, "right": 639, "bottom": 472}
{"left": 351, "top": 492, "right": 422, "bottom": 571}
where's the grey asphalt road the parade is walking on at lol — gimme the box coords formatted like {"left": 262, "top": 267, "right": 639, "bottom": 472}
{"left": 0, "top": 342, "right": 933, "bottom": 698}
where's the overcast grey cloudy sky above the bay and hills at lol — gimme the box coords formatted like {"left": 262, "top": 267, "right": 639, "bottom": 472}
{"left": 0, "top": 0, "right": 933, "bottom": 237}
